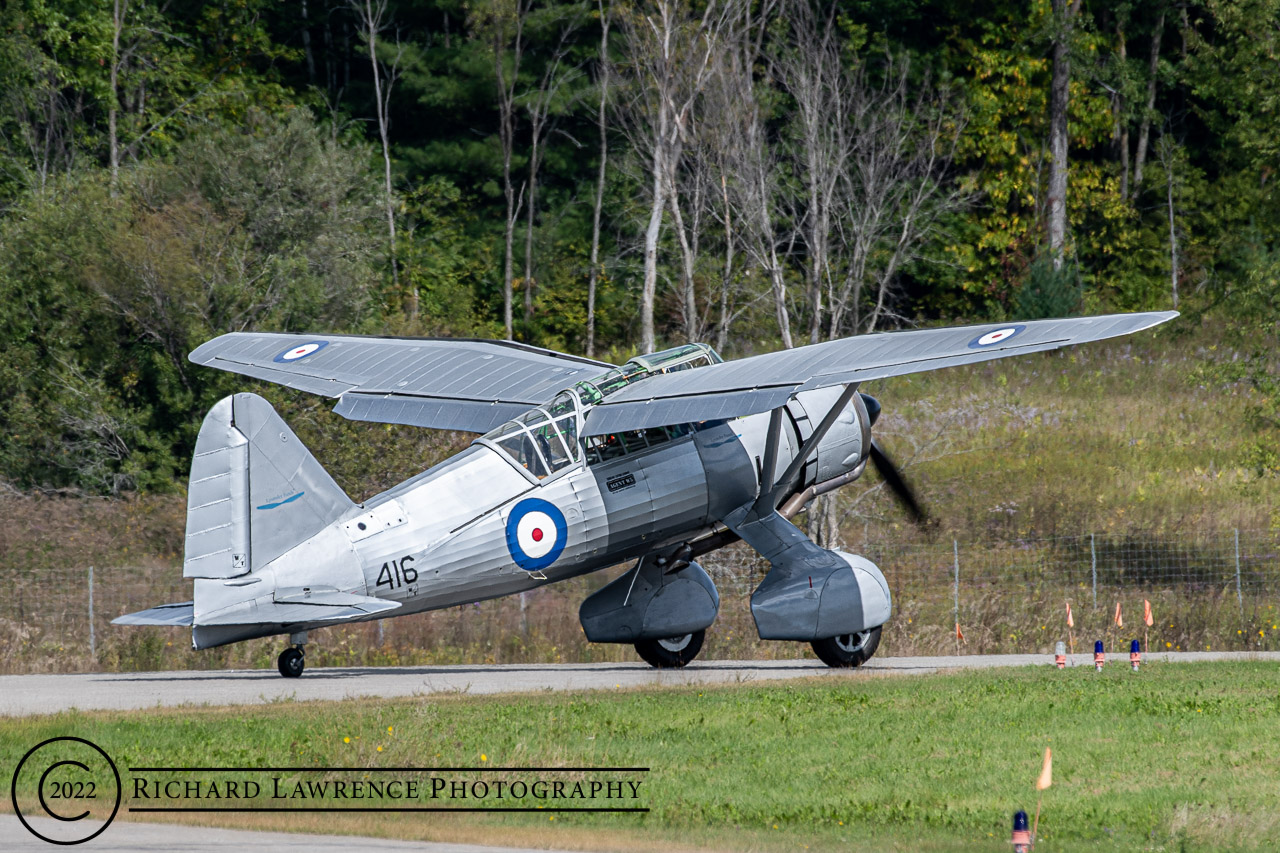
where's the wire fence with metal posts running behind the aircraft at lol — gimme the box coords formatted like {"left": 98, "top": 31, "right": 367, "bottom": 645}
{"left": 0, "top": 530, "right": 1280, "bottom": 672}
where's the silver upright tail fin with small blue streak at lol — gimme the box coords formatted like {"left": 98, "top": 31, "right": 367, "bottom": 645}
{"left": 182, "top": 393, "right": 355, "bottom": 578}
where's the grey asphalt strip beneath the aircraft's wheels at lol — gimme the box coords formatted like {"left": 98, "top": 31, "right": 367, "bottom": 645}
{"left": 0, "top": 652, "right": 1280, "bottom": 716}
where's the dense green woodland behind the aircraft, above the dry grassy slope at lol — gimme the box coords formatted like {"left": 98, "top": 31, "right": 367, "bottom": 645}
{"left": 0, "top": 0, "right": 1280, "bottom": 493}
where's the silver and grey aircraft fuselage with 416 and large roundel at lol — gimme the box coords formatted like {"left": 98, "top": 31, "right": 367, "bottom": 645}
{"left": 193, "top": 388, "right": 868, "bottom": 648}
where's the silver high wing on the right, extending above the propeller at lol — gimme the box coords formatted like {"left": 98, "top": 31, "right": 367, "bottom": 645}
{"left": 584, "top": 311, "right": 1178, "bottom": 435}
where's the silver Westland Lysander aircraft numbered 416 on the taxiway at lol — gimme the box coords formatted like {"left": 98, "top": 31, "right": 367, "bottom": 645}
{"left": 115, "top": 311, "right": 1176, "bottom": 678}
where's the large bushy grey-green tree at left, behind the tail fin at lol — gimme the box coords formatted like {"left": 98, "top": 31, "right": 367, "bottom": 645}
{"left": 0, "top": 109, "right": 380, "bottom": 492}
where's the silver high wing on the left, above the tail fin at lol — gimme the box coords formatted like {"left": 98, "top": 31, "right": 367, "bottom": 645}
{"left": 189, "top": 332, "right": 613, "bottom": 433}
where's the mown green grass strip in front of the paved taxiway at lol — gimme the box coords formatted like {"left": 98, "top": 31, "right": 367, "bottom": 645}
{"left": 0, "top": 662, "right": 1280, "bottom": 850}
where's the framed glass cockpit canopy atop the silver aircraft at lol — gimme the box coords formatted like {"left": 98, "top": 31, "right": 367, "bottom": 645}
{"left": 480, "top": 343, "right": 723, "bottom": 479}
